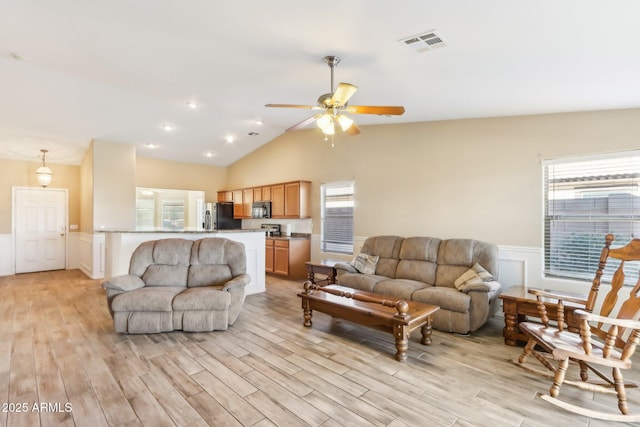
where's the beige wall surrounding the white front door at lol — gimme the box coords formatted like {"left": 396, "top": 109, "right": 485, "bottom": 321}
{"left": 0, "top": 159, "right": 80, "bottom": 234}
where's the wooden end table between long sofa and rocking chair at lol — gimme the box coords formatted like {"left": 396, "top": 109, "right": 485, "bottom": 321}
{"left": 500, "top": 286, "right": 587, "bottom": 345}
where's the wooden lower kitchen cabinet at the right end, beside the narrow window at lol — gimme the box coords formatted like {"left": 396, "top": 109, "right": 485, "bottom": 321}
{"left": 265, "top": 239, "right": 311, "bottom": 279}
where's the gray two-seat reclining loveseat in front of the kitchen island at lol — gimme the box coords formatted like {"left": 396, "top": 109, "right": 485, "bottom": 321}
{"left": 102, "top": 237, "right": 251, "bottom": 334}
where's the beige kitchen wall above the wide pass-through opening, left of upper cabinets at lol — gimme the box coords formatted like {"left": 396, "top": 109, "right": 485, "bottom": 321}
{"left": 136, "top": 157, "right": 227, "bottom": 202}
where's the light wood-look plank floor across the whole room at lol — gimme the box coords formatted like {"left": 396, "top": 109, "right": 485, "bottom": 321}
{"left": 0, "top": 270, "right": 640, "bottom": 427}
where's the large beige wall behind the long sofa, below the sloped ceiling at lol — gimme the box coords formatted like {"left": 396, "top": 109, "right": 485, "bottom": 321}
{"left": 227, "top": 109, "right": 640, "bottom": 247}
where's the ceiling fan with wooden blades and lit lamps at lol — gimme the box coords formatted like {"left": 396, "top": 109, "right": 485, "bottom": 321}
{"left": 265, "top": 56, "right": 404, "bottom": 135}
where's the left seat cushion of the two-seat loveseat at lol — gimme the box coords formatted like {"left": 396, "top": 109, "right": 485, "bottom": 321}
{"left": 111, "top": 286, "right": 186, "bottom": 311}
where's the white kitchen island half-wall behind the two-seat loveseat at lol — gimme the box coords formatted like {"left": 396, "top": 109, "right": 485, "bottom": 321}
{"left": 103, "top": 229, "right": 266, "bottom": 295}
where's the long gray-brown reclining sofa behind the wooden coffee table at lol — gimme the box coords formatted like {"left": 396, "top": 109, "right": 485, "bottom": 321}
{"left": 336, "top": 236, "right": 501, "bottom": 334}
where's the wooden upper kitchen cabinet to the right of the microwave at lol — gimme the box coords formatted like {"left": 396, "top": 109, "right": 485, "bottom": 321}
{"left": 271, "top": 181, "right": 311, "bottom": 218}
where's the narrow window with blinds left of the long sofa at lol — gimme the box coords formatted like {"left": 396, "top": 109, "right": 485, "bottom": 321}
{"left": 320, "top": 181, "right": 354, "bottom": 254}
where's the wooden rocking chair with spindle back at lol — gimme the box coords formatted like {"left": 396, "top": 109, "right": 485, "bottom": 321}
{"left": 518, "top": 234, "right": 640, "bottom": 422}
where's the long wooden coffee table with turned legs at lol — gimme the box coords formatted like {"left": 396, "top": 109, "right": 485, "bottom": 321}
{"left": 298, "top": 281, "right": 440, "bottom": 362}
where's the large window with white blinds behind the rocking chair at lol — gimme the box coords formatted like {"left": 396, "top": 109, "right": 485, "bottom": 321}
{"left": 543, "top": 151, "right": 640, "bottom": 284}
